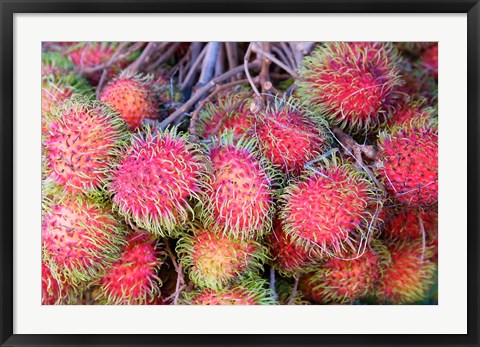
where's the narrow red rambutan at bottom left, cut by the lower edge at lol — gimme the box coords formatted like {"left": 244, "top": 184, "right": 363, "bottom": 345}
{"left": 99, "top": 232, "right": 162, "bottom": 305}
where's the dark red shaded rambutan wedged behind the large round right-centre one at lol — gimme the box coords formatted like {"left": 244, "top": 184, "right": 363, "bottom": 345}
{"left": 266, "top": 220, "right": 321, "bottom": 277}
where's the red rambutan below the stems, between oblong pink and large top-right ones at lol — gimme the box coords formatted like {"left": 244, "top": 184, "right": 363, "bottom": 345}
{"left": 255, "top": 109, "right": 326, "bottom": 175}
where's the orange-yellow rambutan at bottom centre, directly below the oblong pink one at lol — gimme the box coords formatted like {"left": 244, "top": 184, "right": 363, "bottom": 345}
{"left": 176, "top": 224, "right": 267, "bottom": 290}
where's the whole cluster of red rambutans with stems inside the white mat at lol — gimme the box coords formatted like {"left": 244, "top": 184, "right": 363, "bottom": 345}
{"left": 42, "top": 42, "right": 438, "bottom": 305}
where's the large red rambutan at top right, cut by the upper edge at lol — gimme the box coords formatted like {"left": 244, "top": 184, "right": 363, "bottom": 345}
{"left": 298, "top": 42, "right": 402, "bottom": 133}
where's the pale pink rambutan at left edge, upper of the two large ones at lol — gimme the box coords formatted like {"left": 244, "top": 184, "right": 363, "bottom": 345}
{"left": 43, "top": 98, "right": 127, "bottom": 194}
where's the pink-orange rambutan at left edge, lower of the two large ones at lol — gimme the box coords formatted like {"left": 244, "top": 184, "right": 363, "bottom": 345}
{"left": 42, "top": 196, "right": 125, "bottom": 286}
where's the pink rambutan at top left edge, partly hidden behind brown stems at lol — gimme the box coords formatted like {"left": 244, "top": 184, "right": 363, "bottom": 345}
{"left": 68, "top": 42, "right": 128, "bottom": 86}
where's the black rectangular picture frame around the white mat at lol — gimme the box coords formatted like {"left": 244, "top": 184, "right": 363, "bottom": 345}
{"left": 0, "top": 0, "right": 480, "bottom": 346}
